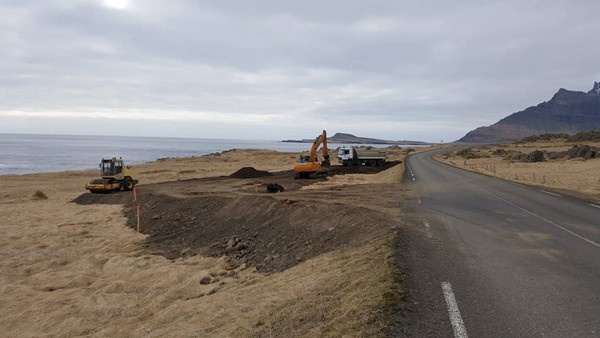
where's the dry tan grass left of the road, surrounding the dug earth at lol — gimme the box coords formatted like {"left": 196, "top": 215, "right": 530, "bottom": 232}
{"left": 0, "top": 151, "right": 404, "bottom": 337}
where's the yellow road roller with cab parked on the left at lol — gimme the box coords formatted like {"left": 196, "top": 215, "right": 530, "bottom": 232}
{"left": 85, "top": 157, "right": 139, "bottom": 194}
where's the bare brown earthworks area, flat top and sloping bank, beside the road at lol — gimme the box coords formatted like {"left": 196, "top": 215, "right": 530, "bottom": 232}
{"left": 74, "top": 161, "right": 401, "bottom": 273}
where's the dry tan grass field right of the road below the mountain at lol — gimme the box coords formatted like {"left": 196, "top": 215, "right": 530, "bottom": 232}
{"left": 437, "top": 140, "right": 600, "bottom": 200}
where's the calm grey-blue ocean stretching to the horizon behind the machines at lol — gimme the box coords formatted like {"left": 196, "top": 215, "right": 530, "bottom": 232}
{"left": 0, "top": 134, "right": 418, "bottom": 175}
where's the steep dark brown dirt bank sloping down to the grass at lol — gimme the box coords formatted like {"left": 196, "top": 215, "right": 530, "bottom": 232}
{"left": 126, "top": 195, "right": 395, "bottom": 272}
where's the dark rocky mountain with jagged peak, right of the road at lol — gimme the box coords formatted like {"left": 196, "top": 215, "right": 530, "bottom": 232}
{"left": 457, "top": 82, "right": 600, "bottom": 143}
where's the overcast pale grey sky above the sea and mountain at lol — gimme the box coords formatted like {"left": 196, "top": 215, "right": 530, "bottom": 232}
{"left": 0, "top": 0, "right": 600, "bottom": 142}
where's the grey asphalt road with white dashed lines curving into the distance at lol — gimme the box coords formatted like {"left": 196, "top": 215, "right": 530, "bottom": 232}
{"left": 403, "top": 152, "right": 600, "bottom": 337}
